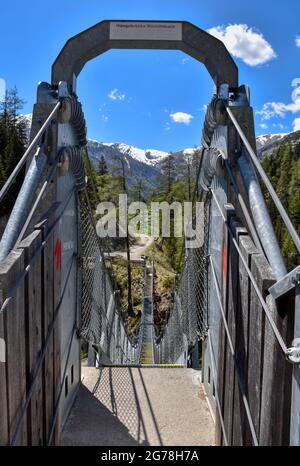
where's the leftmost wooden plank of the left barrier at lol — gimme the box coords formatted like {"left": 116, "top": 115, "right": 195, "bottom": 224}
{"left": 0, "top": 250, "right": 27, "bottom": 445}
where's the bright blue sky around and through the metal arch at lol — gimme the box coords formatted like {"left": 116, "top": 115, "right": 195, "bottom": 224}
{"left": 0, "top": 0, "right": 300, "bottom": 151}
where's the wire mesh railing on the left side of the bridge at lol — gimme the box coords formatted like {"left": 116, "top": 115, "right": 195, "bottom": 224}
{"left": 80, "top": 191, "right": 140, "bottom": 365}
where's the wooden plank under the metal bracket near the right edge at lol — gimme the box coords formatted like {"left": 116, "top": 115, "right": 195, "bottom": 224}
{"left": 260, "top": 290, "right": 295, "bottom": 446}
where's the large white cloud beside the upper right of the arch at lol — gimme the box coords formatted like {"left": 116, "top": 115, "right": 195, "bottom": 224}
{"left": 207, "top": 24, "right": 276, "bottom": 66}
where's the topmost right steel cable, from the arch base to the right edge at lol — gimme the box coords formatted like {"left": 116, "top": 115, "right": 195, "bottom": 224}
{"left": 226, "top": 107, "right": 300, "bottom": 252}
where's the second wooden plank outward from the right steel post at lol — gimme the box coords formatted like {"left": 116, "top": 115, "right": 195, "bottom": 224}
{"left": 232, "top": 235, "right": 258, "bottom": 446}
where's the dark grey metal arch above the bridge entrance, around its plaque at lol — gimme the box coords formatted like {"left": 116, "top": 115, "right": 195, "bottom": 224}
{"left": 52, "top": 20, "right": 238, "bottom": 91}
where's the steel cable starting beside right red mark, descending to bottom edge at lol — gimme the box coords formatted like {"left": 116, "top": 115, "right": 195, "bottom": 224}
{"left": 209, "top": 256, "right": 259, "bottom": 446}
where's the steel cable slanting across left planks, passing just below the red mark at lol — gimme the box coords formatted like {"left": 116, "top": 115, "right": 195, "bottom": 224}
{"left": 10, "top": 254, "right": 77, "bottom": 446}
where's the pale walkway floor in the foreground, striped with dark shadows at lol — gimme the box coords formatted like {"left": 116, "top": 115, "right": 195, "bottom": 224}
{"left": 62, "top": 367, "right": 214, "bottom": 446}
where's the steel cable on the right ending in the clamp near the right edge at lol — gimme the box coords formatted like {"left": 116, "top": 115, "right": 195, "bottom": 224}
{"left": 211, "top": 189, "right": 290, "bottom": 357}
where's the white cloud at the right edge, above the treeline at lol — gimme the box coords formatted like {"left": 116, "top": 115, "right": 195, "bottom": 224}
{"left": 256, "top": 78, "right": 300, "bottom": 120}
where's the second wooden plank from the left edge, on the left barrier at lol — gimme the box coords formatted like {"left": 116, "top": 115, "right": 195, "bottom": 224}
{"left": 19, "top": 231, "right": 43, "bottom": 446}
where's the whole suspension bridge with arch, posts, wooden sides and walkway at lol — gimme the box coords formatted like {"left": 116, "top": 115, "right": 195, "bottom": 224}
{"left": 0, "top": 21, "right": 300, "bottom": 445}
